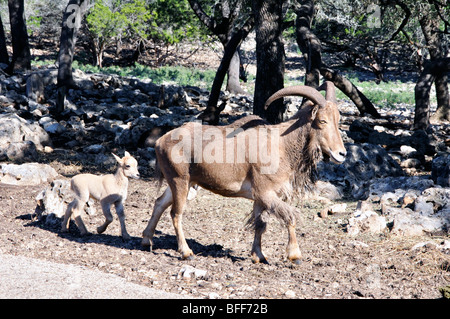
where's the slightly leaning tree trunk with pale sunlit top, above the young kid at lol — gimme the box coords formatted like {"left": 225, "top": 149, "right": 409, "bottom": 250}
{"left": 56, "top": 0, "right": 87, "bottom": 114}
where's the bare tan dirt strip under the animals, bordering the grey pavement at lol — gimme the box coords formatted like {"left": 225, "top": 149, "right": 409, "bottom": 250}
{"left": 0, "top": 172, "right": 450, "bottom": 298}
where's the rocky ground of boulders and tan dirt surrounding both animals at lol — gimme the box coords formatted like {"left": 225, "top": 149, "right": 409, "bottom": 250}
{"left": 0, "top": 45, "right": 450, "bottom": 298}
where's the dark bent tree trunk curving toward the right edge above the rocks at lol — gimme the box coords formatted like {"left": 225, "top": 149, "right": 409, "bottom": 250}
{"left": 414, "top": 58, "right": 450, "bottom": 130}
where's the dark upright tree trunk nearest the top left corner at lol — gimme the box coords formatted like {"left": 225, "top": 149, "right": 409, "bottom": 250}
{"left": 8, "top": 0, "right": 31, "bottom": 74}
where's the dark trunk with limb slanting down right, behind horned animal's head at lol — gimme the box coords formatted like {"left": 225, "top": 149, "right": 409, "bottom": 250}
{"left": 296, "top": 0, "right": 380, "bottom": 118}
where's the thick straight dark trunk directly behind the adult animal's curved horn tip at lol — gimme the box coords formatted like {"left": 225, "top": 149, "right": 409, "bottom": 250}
{"left": 252, "top": 0, "right": 285, "bottom": 123}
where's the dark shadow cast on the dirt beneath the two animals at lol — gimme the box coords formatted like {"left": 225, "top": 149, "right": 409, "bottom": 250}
{"left": 16, "top": 214, "right": 245, "bottom": 262}
